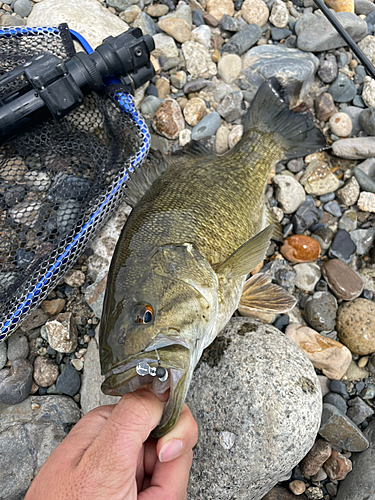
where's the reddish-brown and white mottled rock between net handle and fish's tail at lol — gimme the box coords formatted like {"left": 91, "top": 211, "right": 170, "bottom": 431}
{"left": 152, "top": 99, "right": 185, "bottom": 139}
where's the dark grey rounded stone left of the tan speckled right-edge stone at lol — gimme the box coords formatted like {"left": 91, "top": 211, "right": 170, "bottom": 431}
{"left": 304, "top": 292, "right": 337, "bottom": 332}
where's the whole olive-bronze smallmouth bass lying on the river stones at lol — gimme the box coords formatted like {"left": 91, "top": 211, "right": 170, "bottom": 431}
{"left": 99, "top": 79, "right": 326, "bottom": 437}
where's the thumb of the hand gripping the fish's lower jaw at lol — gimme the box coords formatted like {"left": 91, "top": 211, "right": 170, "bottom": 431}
{"left": 79, "top": 388, "right": 164, "bottom": 484}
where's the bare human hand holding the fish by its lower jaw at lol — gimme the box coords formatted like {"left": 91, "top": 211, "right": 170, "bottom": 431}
{"left": 25, "top": 388, "right": 198, "bottom": 500}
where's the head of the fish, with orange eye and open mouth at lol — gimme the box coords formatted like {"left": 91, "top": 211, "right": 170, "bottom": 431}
{"left": 99, "top": 244, "right": 218, "bottom": 437}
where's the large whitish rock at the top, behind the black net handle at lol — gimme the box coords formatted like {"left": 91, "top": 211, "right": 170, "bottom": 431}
{"left": 27, "top": 0, "right": 129, "bottom": 48}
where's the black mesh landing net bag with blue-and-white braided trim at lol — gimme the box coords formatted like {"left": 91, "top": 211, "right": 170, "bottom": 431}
{"left": 0, "top": 25, "right": 148, "bottom": 340}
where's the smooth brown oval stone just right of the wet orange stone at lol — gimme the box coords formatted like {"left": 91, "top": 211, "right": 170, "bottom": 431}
{"left": 322, "top": 259, "right": 363, "bottom": 300}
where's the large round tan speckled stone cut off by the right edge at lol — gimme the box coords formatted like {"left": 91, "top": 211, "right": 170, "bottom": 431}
{"left": 336, "top": 298, "right": 375, "bottom": 356}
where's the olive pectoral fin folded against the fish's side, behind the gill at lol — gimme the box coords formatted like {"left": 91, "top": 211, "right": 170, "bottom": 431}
{"left": 215, "top": 226, "right": 273, "bottom": 278}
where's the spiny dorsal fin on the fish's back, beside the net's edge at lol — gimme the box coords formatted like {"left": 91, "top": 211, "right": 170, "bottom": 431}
{"left": 124, "top": 150, "right": 168, "bottom": 208}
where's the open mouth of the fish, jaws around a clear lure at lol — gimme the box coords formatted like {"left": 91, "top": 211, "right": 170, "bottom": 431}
{"left": 101, "top": 342, "right": 190, "bottom": 437}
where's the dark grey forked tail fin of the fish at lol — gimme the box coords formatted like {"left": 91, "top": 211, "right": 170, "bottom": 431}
{"left": 244, "top": 78, "right": 328, "bottom": 160}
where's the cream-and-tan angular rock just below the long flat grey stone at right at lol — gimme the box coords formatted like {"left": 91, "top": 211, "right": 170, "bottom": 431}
{"left": 300, "top": 160, "right": 340, "bottom": 196}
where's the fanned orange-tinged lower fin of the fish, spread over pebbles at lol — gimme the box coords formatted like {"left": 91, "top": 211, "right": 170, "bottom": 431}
{"left": 240, "top": 274, "right": 297, "bottom": 314}
